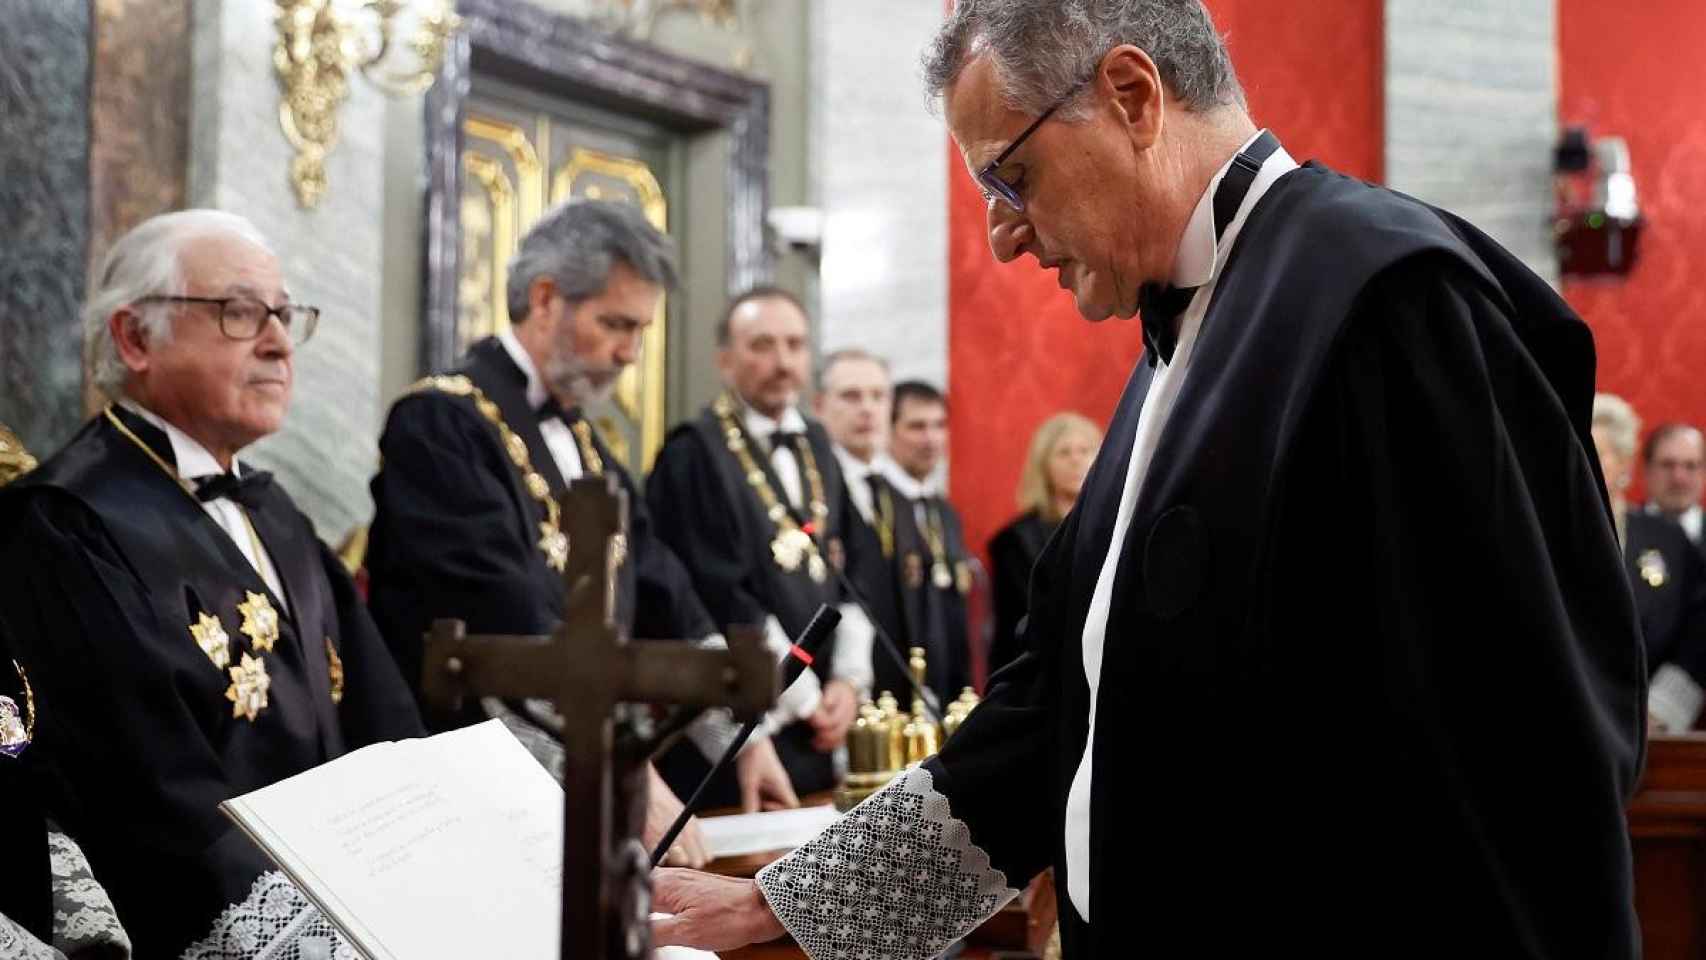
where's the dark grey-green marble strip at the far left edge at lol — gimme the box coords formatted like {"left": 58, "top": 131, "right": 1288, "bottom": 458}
{"left": 0, "top": 0, "right": 90, "bottom": 457}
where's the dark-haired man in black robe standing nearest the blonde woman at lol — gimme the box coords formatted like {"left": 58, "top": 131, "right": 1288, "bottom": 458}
{"left": 877, "top": 380, "right": 972, "bottom": 704}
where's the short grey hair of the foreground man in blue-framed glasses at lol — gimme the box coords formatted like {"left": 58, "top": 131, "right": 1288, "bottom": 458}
{"left": 925, "top": 0, "right": 1247, "bottom": 119}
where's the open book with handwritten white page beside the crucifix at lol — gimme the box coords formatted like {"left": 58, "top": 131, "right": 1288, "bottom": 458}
{"left": 220, "top": 720, "right": 708, "bottom": 960}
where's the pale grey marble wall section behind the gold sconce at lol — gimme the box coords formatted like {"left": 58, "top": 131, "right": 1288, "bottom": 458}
{"left": 189, "top": 0, "right": 388, "bottom": 544}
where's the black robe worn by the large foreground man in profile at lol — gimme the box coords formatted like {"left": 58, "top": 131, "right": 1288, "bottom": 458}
{"left": 926, "top": 164, "right": 1646, "bottom": 960}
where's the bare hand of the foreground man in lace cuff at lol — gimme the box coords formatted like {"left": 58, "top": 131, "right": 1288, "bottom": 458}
{"left": 652, "top": 868, "right": 786, "bottom": 953}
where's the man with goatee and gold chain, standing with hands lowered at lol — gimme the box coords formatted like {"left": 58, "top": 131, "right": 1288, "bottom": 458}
{"left": 647, "top": 286, "right": 872, "bottom": 803}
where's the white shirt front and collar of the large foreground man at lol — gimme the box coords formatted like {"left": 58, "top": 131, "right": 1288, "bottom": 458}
{"left": 1066, "top": 133, "right": 1297, "bottom": 922}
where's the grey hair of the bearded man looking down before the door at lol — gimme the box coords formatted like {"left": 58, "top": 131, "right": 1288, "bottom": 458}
{"left": 507, "top": 200, "right": 679, "bottom": 324}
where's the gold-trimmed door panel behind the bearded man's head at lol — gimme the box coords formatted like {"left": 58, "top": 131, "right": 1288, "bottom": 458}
{"left": 457, "top": 78, "right": 688, "bottom": 476}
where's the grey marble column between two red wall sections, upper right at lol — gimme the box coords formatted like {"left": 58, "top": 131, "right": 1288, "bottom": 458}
{"left": 1385, "top": 0, "right": 1558, "bottom": 281}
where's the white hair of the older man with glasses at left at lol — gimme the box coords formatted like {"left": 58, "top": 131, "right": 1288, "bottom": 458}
{"left": 84, "top": 210, "right": 271, "bottom": 397}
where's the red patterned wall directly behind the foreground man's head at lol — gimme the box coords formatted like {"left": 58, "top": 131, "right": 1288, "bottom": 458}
{"left": 949, "top": 0, "right": 1385, "bottom": 566}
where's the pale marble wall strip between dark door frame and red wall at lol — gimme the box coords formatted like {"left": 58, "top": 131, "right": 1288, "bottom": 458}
{"left": 810, "top": 0, "right": 949, "bottom": 387}
